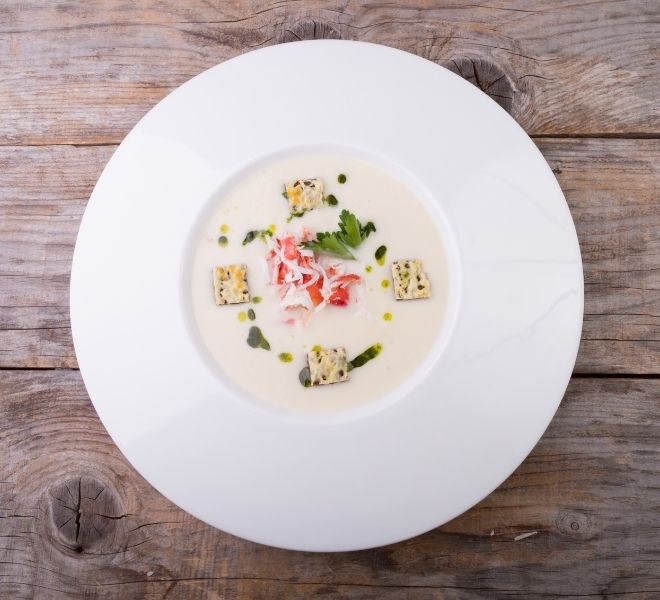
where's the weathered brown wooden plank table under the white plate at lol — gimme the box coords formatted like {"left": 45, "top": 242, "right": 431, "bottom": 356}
{"left": 0, "top": 0, "right": 660, "bottom": 600}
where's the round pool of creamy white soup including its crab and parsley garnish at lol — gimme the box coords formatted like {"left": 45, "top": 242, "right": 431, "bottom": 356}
{"left": 191, "top": 154, "right": 448, "bottom": 412}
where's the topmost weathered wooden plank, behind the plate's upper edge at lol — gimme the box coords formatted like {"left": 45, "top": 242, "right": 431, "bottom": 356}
{"left": 0, "top": 0, "right": 660, "bottom": 145}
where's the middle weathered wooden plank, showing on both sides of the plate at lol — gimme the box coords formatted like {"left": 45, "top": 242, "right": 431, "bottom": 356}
{"left": 0, "top": 139, "right": 660, "bottom": 374}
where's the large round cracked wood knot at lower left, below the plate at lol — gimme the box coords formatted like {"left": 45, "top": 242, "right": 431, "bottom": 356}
{"left": 48, "top": 475, "right": 127, "bottom": 554}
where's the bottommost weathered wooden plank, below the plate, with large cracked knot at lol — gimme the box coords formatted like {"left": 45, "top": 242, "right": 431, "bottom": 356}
{"left": 0, "top": 370, "right": 660, "bottom": 600}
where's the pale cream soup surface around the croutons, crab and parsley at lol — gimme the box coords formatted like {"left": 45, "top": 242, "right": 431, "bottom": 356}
{"left": 192, "top": 154, "right": 448, "bottom": 412}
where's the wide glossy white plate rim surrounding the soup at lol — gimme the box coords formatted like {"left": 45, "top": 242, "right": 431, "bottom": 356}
{"left": 71, "top": 41, "right": 583, "bottom": 550}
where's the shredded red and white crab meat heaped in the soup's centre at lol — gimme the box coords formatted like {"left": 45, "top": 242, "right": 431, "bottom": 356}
{"left": 266, "top": 228, "right": 362, "bottom": 323}
